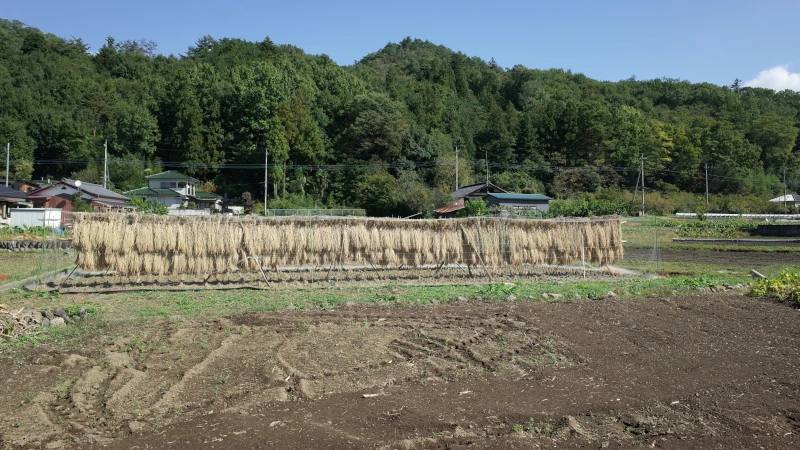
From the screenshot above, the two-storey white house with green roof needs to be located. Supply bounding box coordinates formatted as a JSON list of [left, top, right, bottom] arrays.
[[125, 170, 222, 211]]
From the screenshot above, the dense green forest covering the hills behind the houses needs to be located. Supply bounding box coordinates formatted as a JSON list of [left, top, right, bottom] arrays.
[[0, 19, 800, 215]]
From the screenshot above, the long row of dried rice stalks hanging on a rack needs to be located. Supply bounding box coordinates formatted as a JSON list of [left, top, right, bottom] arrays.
[[74, 214, 622, 275]]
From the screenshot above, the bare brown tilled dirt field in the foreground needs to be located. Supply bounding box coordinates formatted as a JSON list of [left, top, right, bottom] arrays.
[[0, 293, 800, 449]]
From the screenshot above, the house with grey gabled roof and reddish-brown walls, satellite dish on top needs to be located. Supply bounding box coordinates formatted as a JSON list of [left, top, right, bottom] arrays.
[[28, 178, 132, 219]]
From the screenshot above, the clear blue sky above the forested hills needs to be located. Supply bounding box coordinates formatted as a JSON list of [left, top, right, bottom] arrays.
[[6, 0, 800, 90]]
